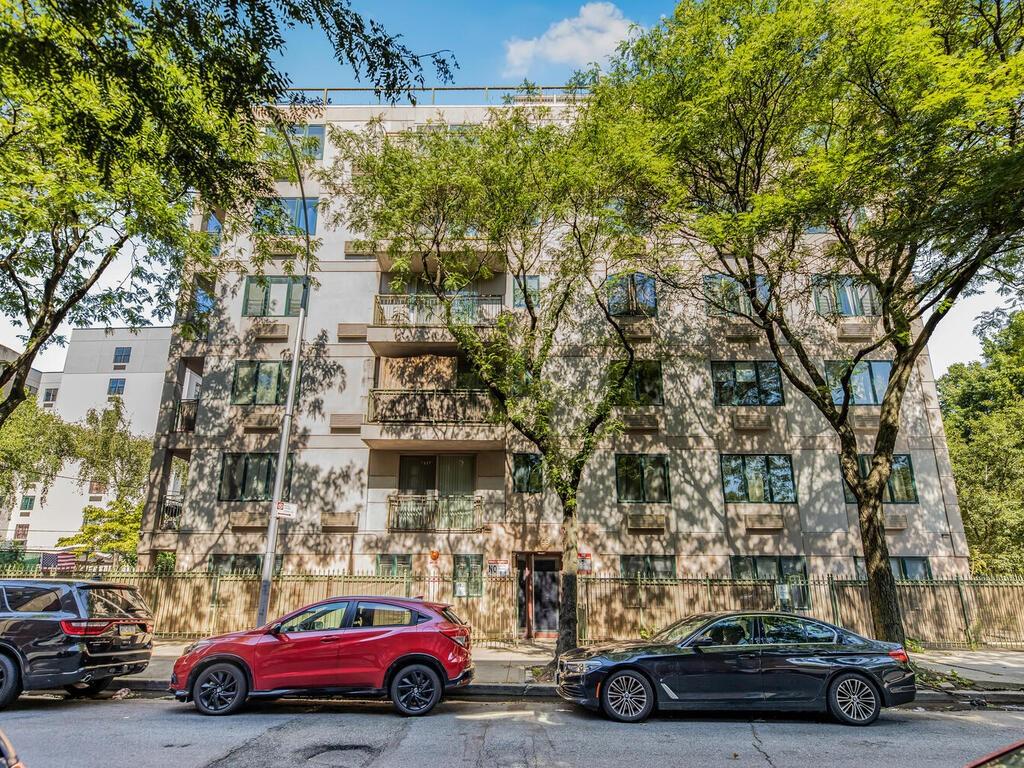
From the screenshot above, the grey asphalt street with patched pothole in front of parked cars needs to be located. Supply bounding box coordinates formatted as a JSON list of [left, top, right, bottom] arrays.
[[0, 695, 1024, 768]]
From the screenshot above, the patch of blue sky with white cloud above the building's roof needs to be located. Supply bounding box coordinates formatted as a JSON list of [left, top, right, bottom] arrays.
[[282, 0, 674, 88]]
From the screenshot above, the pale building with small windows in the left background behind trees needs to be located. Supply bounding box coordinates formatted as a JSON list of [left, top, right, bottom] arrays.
[[3, 327, 172, 553]]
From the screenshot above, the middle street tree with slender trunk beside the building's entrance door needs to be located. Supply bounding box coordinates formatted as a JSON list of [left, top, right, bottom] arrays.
[[322, 105, 654, 651]]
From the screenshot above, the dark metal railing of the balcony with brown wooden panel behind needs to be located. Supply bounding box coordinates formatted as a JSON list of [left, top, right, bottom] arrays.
[[367, 389, 494, 424]]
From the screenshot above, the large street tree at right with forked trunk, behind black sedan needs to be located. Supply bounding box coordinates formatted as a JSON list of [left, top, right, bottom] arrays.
[[594, 0, 1024, 641]]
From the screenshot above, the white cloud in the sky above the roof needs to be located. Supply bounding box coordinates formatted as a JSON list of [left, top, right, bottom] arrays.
[[505, 2, 632, 77]]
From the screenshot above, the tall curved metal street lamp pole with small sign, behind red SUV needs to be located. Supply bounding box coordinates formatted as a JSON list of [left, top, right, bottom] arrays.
[[256, 125, 310, 627]]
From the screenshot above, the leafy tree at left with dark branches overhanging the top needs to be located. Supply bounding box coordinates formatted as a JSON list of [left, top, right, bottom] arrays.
[[0, 0, 454, 424]]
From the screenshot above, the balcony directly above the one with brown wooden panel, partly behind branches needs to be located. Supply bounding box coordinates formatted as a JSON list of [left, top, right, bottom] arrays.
[[367, 294, 504, 355]]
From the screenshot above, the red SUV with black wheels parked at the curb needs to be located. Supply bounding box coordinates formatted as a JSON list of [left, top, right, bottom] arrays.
[[171, 596, 473, 715]]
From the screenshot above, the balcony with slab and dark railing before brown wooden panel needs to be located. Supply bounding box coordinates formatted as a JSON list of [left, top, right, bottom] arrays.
[[360, 389, 505, 451]]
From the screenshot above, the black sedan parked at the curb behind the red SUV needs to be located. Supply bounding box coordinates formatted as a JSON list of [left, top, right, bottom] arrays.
[[557, 611, 916, 725]]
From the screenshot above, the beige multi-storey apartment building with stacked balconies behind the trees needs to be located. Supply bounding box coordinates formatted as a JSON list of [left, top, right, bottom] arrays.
[[139, 105, 968, 632]]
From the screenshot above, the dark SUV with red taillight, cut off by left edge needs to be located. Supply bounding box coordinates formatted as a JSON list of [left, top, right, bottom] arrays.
[[0, 579, 153, 708]]
